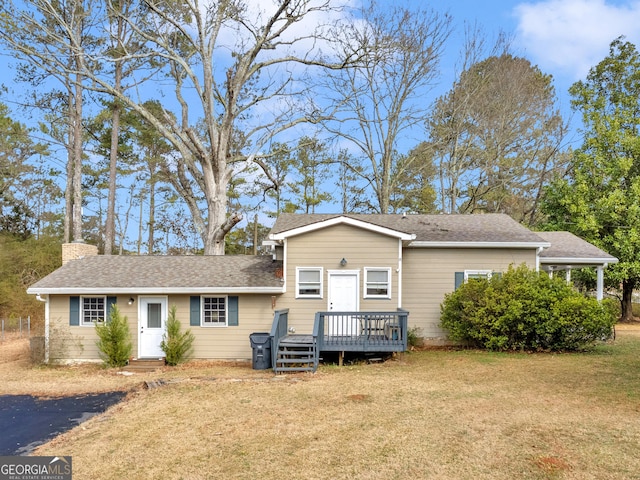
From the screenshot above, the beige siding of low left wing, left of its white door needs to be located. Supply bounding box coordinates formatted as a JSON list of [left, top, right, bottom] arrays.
[[49, 295, 138, 363]]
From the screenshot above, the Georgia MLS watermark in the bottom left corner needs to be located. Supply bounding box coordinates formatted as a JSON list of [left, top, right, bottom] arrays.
[[0, 456, 71, 480]]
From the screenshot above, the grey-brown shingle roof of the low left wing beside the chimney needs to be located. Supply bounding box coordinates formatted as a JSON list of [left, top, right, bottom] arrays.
[[30, 255, 282, 291]]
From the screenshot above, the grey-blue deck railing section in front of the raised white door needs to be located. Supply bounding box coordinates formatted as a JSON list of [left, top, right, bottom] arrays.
[[313, 309, 409, 352]]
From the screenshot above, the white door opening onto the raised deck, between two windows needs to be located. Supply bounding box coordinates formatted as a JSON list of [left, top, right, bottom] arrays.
[[327, 271, 360, 336]]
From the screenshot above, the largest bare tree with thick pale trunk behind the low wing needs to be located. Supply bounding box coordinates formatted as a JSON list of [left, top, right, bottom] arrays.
[[10, 0, 358, 254]]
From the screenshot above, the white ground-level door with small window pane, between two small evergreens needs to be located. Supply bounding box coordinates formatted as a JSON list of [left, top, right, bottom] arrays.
[[138, 297, 167, 358]]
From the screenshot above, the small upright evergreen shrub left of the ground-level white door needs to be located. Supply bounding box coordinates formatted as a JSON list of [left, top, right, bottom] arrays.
[[96, 305, 133, 367]]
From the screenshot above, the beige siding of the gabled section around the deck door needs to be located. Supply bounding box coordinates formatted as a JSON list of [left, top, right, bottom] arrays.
[[277, 225, 399, 333]]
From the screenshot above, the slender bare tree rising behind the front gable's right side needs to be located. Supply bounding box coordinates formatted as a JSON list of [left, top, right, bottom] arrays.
[[322, 2, 451, 213]]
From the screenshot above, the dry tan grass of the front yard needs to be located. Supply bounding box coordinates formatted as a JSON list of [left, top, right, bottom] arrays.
[[0, 326, 640, 479]]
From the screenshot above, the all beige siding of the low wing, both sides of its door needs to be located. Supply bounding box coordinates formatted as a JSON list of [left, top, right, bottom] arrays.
[[49, 295, 273, 363]]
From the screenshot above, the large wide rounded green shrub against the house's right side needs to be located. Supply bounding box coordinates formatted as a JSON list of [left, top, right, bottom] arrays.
[[441, 265, 616, 351]]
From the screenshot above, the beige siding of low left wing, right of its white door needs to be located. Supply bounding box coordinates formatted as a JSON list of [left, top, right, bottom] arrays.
[[169, 294, 273, 360]]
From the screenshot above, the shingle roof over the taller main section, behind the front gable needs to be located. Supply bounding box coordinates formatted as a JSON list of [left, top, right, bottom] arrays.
[[271, 213, 545, 243]]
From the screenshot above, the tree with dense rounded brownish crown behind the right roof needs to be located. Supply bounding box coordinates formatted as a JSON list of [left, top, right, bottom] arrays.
[[427, 47, 567, 225]]
